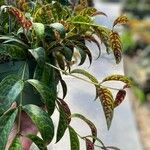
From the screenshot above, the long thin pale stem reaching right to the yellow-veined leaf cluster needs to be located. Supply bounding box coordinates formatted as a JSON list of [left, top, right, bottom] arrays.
[[46, 63, 120, 91]]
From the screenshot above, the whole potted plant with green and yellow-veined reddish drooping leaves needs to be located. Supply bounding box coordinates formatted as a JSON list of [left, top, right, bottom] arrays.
[[0, 0, 131, 150]]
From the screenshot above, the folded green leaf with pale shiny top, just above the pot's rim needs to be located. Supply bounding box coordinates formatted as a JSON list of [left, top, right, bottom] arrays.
[[29, 47, 45, 66]]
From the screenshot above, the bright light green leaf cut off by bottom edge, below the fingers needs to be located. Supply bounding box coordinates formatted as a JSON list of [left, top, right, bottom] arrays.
[[9, 137, 22, 150]]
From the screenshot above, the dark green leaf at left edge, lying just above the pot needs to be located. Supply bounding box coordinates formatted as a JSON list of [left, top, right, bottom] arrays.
[[0, 44, 27, 60]]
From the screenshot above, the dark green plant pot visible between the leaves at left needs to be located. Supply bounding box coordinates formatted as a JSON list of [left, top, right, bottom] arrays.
[[0, 61, 43, 106]]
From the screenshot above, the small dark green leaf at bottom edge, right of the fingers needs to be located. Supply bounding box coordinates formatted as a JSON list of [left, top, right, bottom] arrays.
[[27, 134, 47, 150]]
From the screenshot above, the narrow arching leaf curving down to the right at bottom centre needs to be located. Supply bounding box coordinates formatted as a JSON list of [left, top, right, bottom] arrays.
[[71, 113, 97, 143]]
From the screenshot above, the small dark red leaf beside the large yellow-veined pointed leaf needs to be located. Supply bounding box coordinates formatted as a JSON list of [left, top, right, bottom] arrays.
[[114, 90, 126, 107]]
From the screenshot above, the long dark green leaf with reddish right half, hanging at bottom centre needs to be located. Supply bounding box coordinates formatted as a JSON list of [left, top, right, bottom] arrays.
[[56, 100, 71, 142]]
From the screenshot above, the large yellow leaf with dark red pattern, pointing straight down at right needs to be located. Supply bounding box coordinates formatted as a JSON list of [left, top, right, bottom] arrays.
[[98, 87, 114, 130]]
